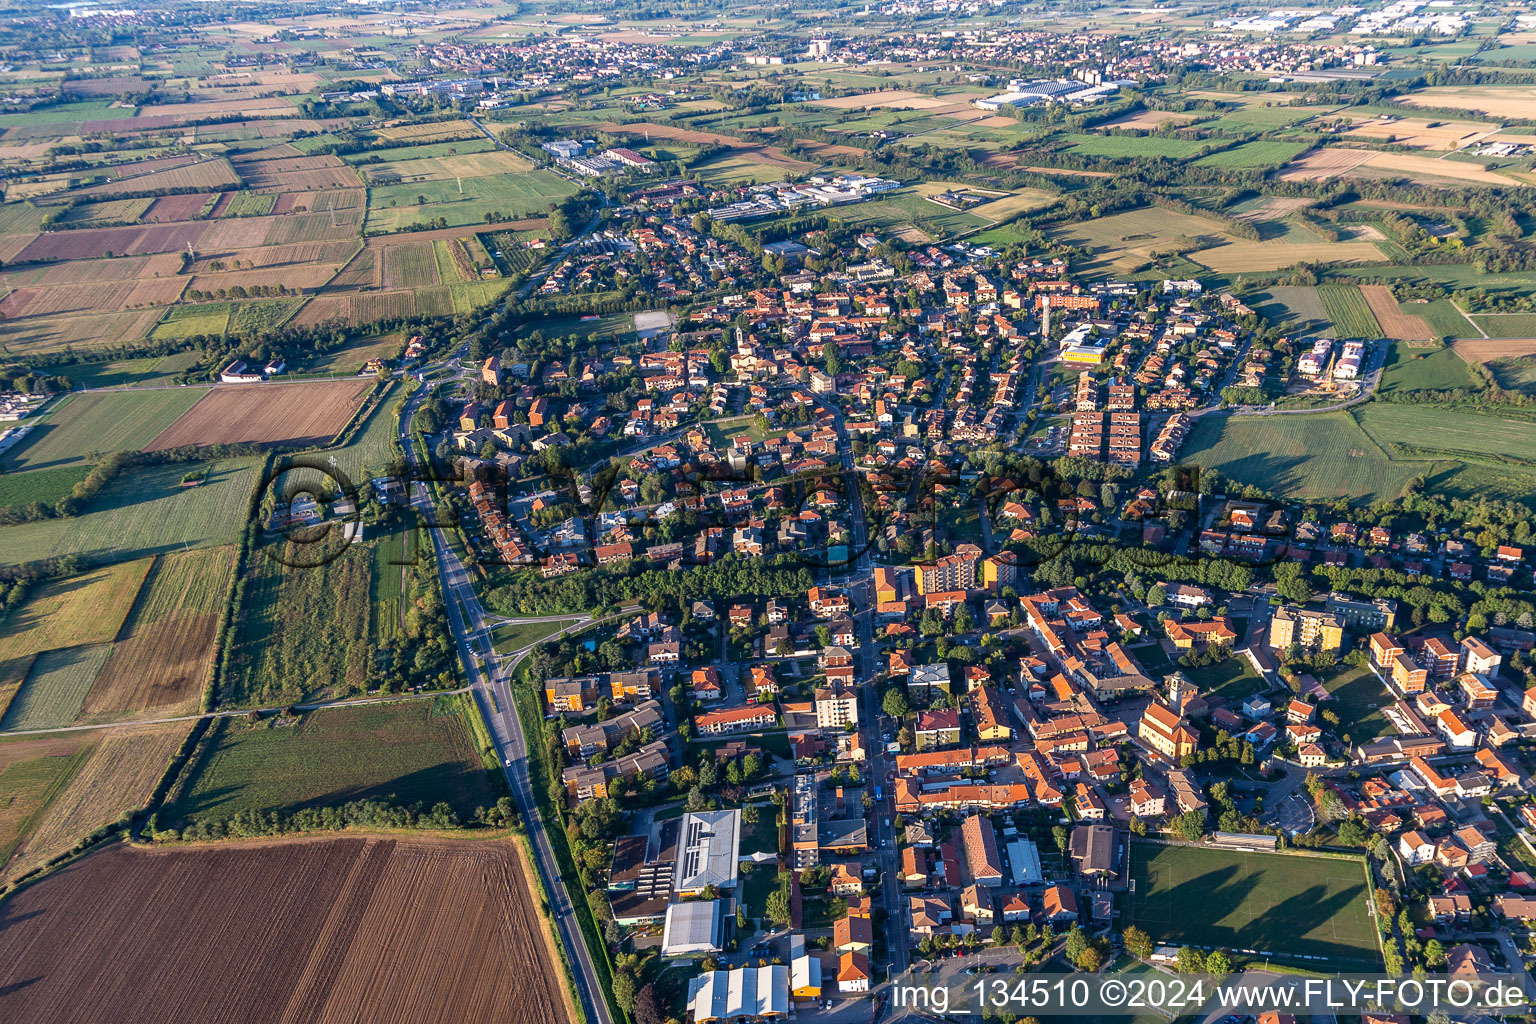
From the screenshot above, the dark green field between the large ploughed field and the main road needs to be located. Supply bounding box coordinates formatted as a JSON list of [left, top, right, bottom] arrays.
[[161, 694, 496, 827]]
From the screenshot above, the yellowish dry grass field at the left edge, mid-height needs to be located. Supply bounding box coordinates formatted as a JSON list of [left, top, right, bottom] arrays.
[[0, 559, 151, 665]]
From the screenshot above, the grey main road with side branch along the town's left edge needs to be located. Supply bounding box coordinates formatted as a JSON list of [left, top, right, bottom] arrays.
[[399, 379, 613, 1024]]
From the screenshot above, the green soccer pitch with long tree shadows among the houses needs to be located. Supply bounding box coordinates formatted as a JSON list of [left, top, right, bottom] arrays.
[[1127, 843, 1381, 966]]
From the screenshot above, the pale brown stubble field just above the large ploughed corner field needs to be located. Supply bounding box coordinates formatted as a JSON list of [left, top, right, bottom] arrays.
[[0, 722, 192, 880]]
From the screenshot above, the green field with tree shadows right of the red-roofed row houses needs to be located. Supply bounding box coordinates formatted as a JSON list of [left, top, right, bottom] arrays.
[[1181, 411, 1428, 502]]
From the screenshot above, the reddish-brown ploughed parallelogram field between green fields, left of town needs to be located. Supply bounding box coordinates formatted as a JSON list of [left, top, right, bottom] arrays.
[[146, 381, 373, 451]]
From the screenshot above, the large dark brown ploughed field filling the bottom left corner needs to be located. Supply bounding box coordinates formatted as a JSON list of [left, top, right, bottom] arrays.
[[0, 837, 567, 1024]]
